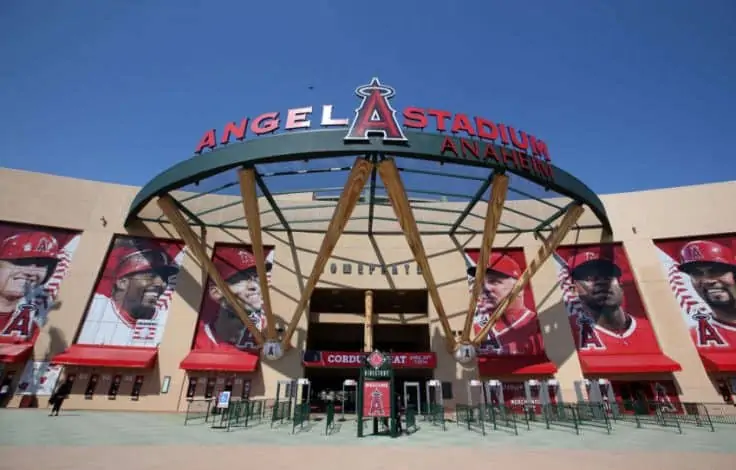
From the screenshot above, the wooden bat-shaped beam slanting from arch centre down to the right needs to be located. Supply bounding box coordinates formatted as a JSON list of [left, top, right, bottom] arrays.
[[378, 159, 455, 352]]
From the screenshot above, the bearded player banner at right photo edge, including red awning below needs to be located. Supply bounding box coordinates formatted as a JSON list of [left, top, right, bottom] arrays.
[[655, 235, 736, 372]]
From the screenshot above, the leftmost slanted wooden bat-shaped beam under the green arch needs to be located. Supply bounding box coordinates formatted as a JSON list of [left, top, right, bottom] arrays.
[[157, 194, 263, 346]]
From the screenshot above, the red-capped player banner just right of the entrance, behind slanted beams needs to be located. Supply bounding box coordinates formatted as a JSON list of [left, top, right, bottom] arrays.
[[465, 250, 544, 356]]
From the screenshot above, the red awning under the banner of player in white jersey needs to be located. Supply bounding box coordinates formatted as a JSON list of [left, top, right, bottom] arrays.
[[52, 344, 158, 369]]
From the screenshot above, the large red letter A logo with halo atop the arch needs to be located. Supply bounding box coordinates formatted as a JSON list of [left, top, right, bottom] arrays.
[[345, 78, 407, 142]]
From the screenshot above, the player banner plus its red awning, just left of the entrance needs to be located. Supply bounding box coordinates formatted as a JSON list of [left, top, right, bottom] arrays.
[[181, 244, 274, 372]]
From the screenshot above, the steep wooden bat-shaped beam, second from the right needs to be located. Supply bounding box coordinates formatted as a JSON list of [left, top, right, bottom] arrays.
[[461, 173, 509, 343]]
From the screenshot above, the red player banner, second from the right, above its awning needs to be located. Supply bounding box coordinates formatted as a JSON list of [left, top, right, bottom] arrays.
[[554, 245, 659, 354]]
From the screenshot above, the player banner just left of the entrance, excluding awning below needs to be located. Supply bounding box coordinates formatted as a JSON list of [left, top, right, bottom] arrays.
[[195, 246, 274, 350]]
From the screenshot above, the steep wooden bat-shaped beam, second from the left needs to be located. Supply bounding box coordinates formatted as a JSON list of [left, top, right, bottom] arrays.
[[238, 168, 276, 340]]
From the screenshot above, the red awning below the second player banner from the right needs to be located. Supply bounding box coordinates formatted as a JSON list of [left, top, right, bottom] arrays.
[[579, 353, 682, 375]]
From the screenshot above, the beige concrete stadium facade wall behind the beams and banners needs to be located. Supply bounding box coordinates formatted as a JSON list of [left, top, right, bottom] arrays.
[[0, 170, 736, 411]]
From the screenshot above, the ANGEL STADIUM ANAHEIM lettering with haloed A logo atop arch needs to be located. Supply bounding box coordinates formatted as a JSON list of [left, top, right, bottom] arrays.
[[194, 78, 553, 180]]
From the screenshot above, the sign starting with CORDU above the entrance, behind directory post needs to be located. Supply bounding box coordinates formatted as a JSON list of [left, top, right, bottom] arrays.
[[302, 350, 437, 369]]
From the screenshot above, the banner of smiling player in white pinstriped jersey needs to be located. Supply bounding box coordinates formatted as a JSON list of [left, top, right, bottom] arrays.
[[77, 236, 184, 347]]
